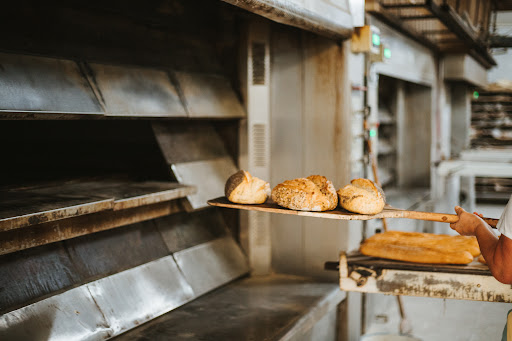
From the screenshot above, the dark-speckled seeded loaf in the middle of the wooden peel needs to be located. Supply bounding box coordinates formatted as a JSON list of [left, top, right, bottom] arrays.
[[272, 175, 338, 212]]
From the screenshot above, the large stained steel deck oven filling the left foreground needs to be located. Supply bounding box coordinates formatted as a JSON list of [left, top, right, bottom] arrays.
[[0, 0, 358, 340]]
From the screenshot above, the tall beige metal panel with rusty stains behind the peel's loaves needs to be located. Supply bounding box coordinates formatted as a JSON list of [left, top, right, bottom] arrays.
[[270, 22, 351, 279]]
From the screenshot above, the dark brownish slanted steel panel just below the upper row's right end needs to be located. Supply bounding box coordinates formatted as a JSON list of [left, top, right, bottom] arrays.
[[152, 122, 228, 164]]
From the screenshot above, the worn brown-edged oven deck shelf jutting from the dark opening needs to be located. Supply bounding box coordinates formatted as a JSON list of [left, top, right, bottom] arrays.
[[0, 180, 195, 232]]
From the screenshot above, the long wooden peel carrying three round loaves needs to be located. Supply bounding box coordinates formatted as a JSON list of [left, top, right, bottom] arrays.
[[208, 197, 498, 228]]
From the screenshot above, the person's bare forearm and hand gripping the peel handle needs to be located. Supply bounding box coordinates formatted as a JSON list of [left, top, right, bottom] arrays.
[[450, 206, 512, 284]]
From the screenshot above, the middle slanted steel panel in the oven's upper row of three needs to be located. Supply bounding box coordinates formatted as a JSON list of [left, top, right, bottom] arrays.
[[90, 64, 187, 117]]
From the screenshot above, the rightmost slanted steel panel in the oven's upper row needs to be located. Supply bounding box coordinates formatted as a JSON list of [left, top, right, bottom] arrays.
[[176, 72, 245, 118]]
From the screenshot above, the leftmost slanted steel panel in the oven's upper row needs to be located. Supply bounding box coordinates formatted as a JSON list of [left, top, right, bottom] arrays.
[[0, 53, 103, 114]]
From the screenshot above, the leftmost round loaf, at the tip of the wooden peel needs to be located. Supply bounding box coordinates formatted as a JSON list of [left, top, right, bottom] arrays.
[[224, 170, 270, 204]]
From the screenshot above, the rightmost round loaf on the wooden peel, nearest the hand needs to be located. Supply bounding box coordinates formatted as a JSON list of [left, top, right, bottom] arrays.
[[337, 179, 386, 214]]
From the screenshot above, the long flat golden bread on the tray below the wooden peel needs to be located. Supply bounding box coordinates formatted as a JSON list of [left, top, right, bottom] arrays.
[[359, 231, 480, 264]]
